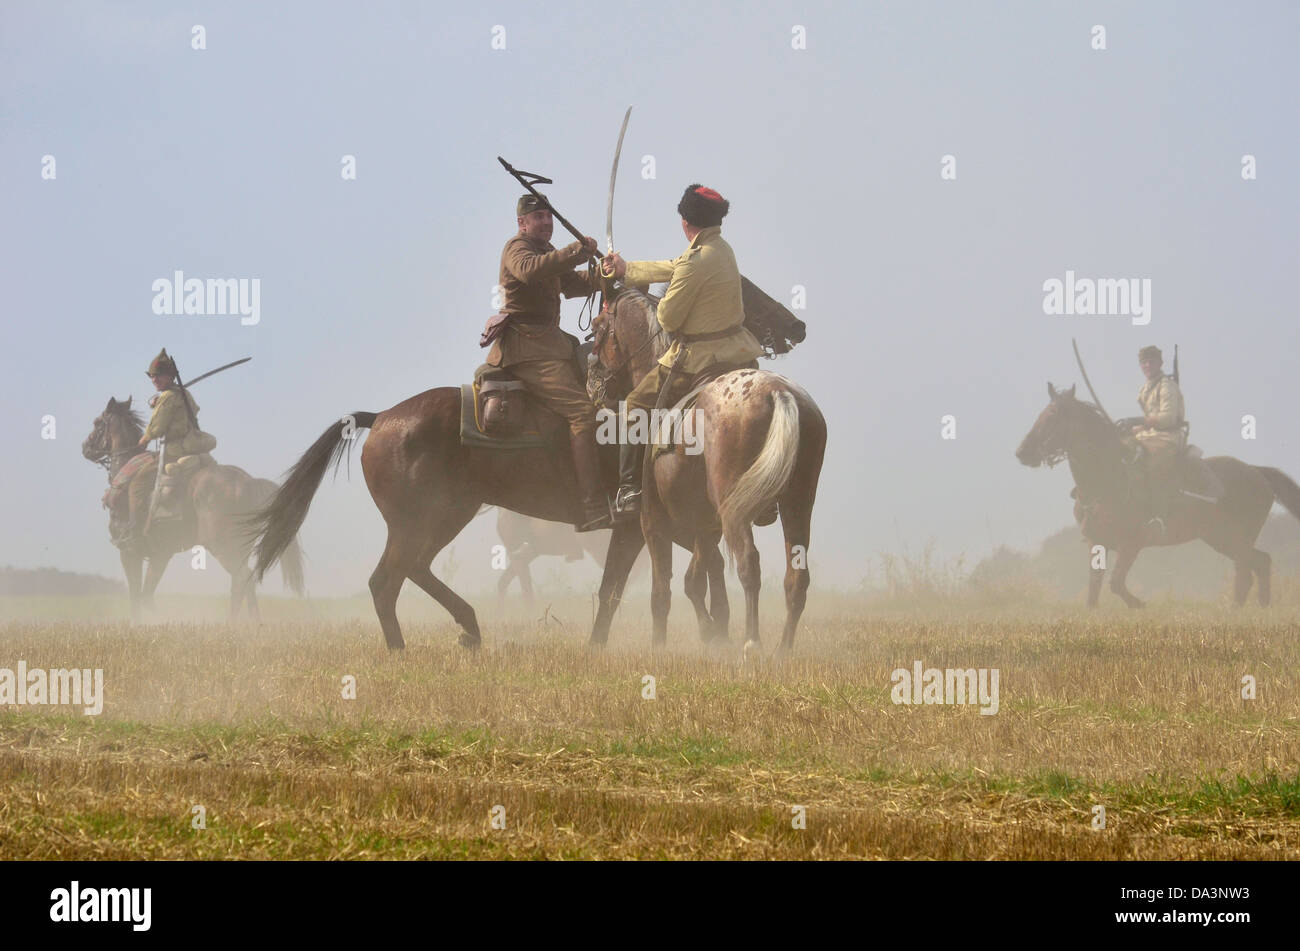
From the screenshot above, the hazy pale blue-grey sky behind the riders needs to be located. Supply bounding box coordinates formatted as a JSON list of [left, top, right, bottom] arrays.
[[0, 0, 1300, 595]]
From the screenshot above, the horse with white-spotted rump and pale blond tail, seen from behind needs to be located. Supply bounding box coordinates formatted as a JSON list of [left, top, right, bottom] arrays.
[[589, 288, 827, 656]]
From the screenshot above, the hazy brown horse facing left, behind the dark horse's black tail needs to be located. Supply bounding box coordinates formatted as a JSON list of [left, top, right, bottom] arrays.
[[82, 398, 304, 621]]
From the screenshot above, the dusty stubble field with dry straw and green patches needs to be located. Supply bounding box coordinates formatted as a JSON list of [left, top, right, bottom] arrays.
[[0, 589, 1300, 859]]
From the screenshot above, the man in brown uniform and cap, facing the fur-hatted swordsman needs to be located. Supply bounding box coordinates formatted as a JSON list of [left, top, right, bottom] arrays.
[[488, 194, 611, 531]]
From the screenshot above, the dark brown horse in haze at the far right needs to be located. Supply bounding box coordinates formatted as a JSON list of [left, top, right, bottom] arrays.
[[1015, 383, 1300, 608]]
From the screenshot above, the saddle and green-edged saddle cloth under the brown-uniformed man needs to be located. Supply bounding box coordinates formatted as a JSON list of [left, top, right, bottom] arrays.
[[460, 364, 568, 450]]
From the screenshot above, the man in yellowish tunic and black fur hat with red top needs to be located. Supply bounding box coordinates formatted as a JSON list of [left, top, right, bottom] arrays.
[[603, 183, 763, 516]]
